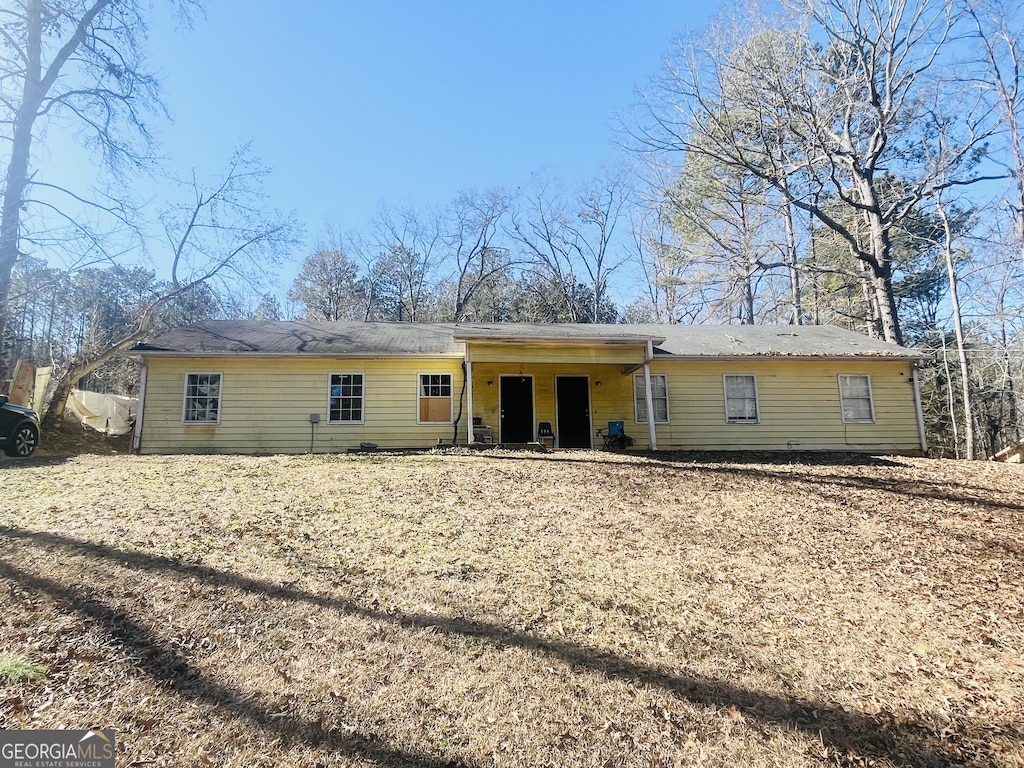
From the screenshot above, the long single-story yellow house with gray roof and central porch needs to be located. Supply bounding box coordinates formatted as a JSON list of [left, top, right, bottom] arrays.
[[128, 321, 927, 454]]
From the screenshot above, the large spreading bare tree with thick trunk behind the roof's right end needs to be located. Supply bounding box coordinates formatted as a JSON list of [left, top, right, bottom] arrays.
[[635, 0, 986, 342]]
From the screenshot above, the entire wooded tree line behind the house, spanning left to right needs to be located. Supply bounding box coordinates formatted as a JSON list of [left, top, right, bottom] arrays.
[[0, 0, 1024, 456]]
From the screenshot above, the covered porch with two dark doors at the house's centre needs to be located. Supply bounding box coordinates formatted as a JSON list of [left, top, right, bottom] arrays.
[[455, 326, 665, 450]]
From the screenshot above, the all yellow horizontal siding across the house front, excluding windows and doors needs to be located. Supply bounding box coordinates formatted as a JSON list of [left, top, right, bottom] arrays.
[[141, 352, 920, 453]]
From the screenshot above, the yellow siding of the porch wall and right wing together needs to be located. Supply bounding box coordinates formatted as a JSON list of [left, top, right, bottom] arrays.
[[471, 358, 921, 452]]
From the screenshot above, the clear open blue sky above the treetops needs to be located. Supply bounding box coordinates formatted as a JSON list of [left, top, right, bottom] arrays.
[[142, 0, 714, 243]]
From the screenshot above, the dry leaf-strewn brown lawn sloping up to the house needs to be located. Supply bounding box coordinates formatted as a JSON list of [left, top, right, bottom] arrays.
[[0, 453, 1024, 768]]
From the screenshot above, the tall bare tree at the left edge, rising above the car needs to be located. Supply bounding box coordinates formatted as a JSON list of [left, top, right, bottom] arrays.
[[0, 0, 193, 378]]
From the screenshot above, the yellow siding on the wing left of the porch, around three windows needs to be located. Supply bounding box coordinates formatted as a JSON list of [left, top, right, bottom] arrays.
[[140, 357, 469, 454]]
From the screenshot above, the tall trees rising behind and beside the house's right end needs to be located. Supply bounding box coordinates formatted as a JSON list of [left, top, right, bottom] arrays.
[[632, 0, 1024, 458]]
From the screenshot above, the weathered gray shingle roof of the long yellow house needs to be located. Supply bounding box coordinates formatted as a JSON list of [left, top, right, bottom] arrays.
[[135, 321, 924, 358]]
